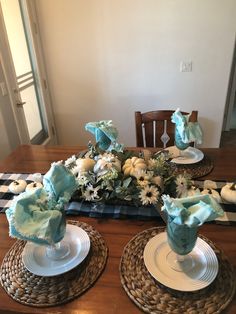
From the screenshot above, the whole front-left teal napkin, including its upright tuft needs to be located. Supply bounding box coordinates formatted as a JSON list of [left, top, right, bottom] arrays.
[[6, 163, 77, 245]]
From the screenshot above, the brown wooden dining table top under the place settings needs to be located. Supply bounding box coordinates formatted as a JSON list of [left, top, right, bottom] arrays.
[[0, 145, 236, 314]]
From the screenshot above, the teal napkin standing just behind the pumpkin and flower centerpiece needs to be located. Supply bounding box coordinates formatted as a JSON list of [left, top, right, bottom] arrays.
[[85, 120, 123, 151]]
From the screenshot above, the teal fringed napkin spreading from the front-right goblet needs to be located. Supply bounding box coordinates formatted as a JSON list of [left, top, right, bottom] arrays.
[[162, 194, 224, 227]]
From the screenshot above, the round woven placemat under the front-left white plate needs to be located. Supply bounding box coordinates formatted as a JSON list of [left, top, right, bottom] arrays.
[[0, 221, 108, 307]]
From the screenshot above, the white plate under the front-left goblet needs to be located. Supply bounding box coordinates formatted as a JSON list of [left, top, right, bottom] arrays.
[[22, 224, 90, 276]]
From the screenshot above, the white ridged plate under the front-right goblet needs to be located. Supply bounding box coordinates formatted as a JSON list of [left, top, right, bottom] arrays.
[[144, 232, 219, 291]]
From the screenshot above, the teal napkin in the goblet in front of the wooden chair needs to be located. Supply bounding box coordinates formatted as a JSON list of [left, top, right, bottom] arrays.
[[171, 109, 203, 144]]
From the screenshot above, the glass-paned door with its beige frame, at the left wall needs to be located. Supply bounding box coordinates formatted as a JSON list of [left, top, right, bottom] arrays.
[[0, 0, 57, 144]]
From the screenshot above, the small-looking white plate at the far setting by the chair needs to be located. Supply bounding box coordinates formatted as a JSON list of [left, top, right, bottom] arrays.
[[165, 146, 204, 165]]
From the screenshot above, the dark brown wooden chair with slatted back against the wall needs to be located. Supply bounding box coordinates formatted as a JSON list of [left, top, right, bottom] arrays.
[[135, 110, 198, 148]]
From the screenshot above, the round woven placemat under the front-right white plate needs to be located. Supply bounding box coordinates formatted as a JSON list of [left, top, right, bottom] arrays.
[[120, 227, 235, 314]]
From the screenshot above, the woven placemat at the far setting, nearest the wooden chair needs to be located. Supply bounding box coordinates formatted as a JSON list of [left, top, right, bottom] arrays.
[[171, 155, 214, 179]]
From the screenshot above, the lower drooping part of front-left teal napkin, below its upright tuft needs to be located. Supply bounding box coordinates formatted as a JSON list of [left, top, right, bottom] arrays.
[[6, 188, 65, 244]]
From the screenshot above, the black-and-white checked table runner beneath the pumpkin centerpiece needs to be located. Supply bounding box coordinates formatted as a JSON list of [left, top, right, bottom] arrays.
[[0, 173, 236, 225]]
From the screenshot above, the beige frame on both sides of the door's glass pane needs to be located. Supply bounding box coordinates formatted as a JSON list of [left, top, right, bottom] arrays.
[[0, 0, 57, 145]]
